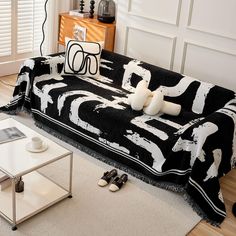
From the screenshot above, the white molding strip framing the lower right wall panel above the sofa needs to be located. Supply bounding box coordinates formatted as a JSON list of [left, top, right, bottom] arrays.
[[180, 41, 236, 74]]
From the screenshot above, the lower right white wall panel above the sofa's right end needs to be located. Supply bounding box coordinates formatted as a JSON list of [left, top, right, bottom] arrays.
[[182, 43, 236, 90]]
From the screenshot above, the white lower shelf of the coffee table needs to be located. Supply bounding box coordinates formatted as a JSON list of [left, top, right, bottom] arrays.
[[0, 171, 69, 224]]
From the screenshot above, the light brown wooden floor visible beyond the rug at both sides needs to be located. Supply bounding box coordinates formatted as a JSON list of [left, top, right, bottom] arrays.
[[0, 75, 236, 236]]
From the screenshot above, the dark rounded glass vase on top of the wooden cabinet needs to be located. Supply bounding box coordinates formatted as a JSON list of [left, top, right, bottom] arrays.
[[97, 0, 116, 23]]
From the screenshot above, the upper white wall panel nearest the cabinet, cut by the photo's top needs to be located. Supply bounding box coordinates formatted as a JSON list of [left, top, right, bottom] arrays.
[[129, 0, 181, 24]]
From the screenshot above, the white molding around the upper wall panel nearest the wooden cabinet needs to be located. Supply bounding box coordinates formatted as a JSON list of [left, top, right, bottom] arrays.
[[127, 0, 182, 26]]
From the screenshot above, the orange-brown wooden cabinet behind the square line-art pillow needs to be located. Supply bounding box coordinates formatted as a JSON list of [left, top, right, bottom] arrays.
[[58, 13, 116, 51]]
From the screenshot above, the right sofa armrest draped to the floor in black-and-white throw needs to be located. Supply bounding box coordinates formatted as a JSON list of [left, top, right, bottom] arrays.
[[173, 99, 236, 222]]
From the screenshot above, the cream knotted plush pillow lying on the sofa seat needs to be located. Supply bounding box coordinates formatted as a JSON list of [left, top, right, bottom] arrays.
[[128, 80, 181, 116]]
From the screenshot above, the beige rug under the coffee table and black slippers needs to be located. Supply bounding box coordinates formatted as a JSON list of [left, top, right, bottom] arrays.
[[0, 114, 200, 236]]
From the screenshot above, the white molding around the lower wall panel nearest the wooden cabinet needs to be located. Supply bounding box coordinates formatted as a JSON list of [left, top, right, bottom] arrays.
[[124, 26, 177, 70]]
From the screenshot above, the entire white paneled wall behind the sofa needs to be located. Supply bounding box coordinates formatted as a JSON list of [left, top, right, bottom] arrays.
[[115, 0, 236, 91]]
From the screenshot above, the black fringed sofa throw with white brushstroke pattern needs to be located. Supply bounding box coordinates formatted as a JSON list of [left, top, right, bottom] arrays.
[[1, 51, 236, 224]]
